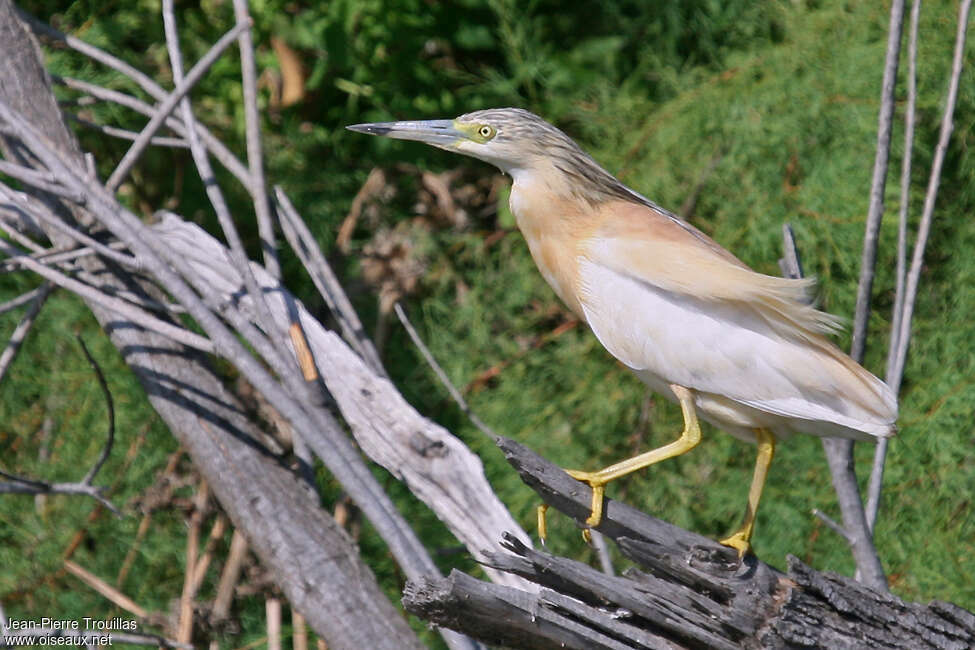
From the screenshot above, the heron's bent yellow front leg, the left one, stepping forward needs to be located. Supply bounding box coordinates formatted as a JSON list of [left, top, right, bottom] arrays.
[[539, 384, 701, 542]]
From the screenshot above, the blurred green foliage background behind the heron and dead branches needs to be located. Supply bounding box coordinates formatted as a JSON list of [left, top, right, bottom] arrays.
[[0, 0, 975, 647]]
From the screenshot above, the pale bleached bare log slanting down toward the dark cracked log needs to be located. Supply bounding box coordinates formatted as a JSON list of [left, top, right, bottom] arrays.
[[153, 215, 532, 589]]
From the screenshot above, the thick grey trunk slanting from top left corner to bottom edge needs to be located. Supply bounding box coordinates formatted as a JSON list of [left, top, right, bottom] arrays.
[[0, 0, 421, 649]]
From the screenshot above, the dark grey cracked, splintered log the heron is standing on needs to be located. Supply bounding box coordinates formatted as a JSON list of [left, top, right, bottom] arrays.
[[403, 440, 975, 650]]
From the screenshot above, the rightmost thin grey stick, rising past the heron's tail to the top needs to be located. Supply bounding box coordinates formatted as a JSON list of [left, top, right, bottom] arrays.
[[867, 0, 972, 529]]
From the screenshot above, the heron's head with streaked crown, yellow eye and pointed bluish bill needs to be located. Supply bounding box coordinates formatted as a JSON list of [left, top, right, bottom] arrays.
[[346, 108, 647, 203]]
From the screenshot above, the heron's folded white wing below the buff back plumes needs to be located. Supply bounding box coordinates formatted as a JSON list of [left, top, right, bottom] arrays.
[[579, 257, 896, 435]]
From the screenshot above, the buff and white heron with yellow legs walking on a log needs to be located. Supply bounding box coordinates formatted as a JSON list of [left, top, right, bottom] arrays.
[[348, 108, 897, 556]]
